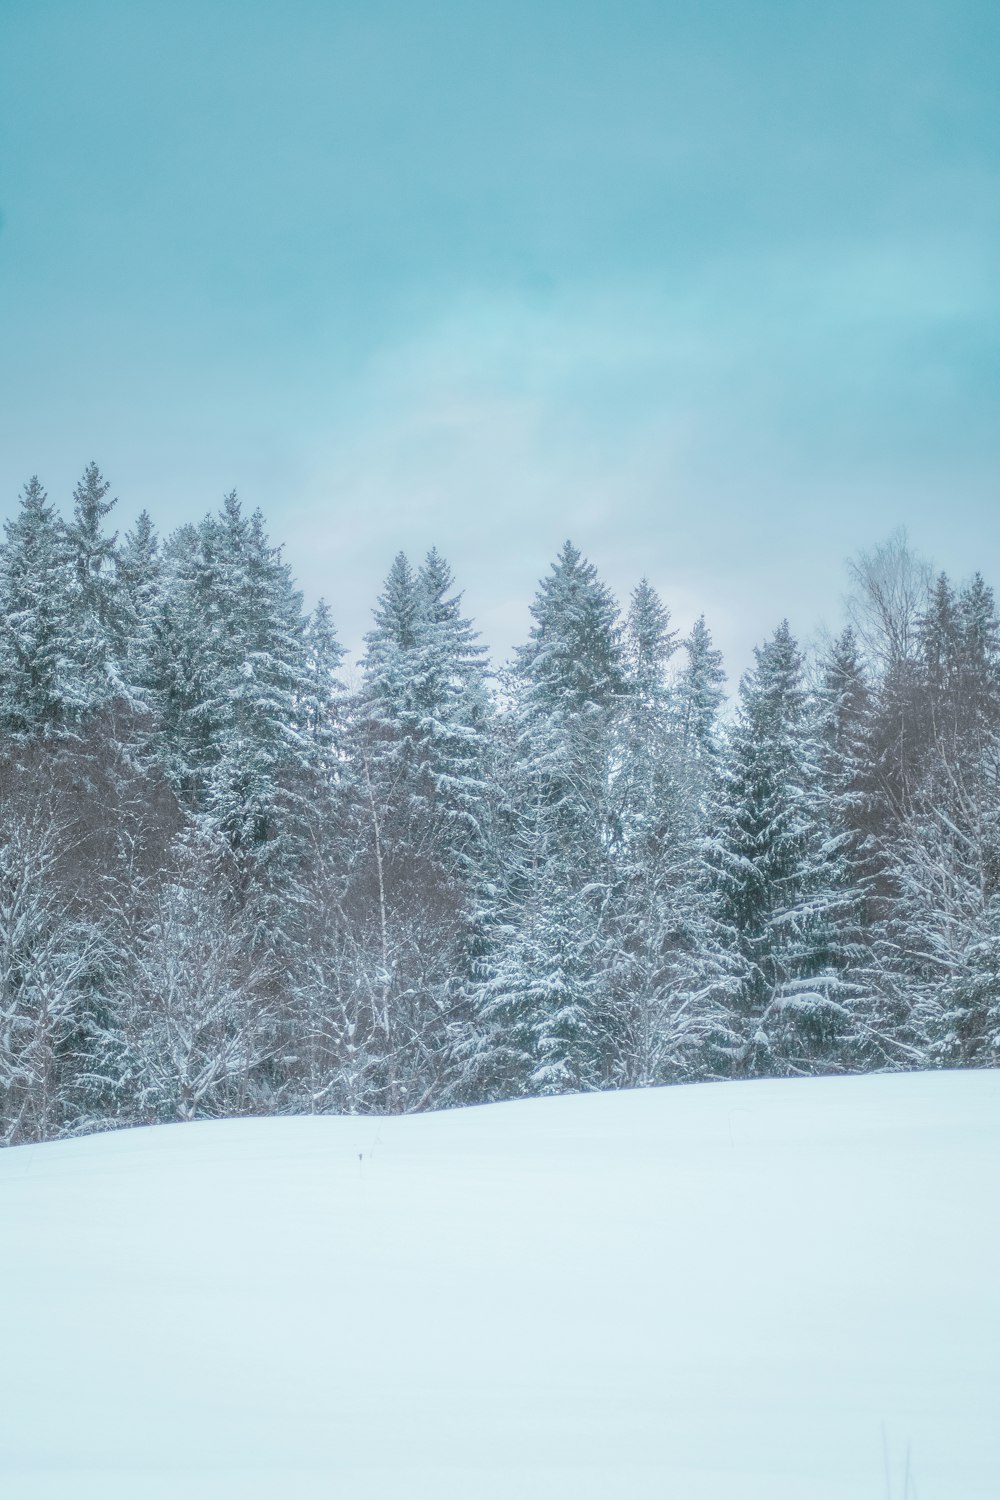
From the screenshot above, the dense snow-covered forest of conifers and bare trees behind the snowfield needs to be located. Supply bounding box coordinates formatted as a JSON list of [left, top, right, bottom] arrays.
[[0, 464, 1000, 1145]]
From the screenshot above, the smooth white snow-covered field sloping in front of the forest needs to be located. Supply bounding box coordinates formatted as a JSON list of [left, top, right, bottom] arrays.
[[0, 1073, 1000, 1500]]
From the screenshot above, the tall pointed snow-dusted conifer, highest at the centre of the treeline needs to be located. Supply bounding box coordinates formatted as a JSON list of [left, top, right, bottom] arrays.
[[478, 542, 628, 1094]]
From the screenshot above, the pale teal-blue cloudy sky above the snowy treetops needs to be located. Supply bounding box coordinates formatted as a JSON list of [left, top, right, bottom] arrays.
[[0, 0, 1000, 674]]
